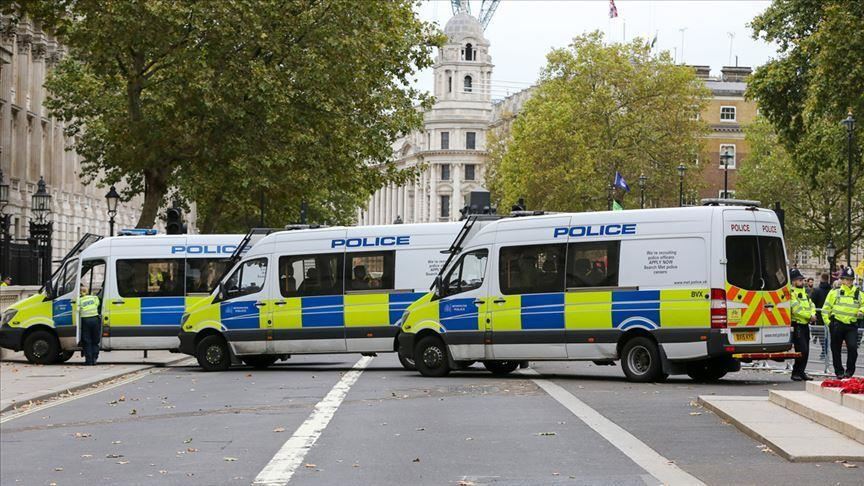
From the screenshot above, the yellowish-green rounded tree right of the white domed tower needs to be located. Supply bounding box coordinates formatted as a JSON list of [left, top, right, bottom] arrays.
[[488, 32, 707, 211]]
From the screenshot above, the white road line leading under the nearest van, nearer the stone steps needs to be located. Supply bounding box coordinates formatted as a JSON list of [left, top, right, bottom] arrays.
[[521, 369, 705, 486]]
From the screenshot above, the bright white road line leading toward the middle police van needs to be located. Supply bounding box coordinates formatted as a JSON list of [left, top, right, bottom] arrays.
[[252, 356, 373, 486]]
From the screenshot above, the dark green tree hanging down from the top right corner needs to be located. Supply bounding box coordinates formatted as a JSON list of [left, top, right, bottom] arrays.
[[741, 0, 864, 260]]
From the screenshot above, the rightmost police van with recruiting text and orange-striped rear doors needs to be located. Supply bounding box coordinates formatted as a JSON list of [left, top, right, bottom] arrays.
[[399, 200, 794, 382]]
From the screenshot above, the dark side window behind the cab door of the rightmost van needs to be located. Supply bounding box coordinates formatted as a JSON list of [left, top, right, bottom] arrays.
[[498, 244, 566, 295]]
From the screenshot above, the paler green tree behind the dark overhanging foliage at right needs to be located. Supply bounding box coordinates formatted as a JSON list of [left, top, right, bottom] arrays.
[[737, 117, 864, 251]]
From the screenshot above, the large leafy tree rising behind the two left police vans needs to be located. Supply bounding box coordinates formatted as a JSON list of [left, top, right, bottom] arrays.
[[35, 0, 441, 231]]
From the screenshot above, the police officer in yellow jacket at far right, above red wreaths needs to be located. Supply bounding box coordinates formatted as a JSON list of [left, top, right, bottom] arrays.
[[822, 268, 864, 378]]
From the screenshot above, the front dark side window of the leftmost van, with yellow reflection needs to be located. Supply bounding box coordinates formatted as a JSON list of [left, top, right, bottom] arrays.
[[117, 258, 185, 297]]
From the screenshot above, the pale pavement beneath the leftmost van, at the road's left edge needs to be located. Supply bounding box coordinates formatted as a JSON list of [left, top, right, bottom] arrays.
[[0, 351, 188, 413]]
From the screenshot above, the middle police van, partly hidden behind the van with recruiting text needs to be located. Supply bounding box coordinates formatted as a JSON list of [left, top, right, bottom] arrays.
[[180, 223, 462, 371]]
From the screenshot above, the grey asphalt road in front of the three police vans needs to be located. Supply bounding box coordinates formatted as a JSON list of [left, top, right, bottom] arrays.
[[0, 355, 864, 485]]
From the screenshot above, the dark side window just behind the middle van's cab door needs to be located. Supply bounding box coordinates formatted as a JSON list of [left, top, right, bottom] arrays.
[[279, 253, 345, 297]]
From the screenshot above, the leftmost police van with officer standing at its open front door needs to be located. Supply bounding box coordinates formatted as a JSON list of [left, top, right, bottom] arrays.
[[0, 234, 242, 364]]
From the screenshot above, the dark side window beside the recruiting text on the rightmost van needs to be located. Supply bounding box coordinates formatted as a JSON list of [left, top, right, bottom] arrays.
[[567, 241, 621, 289]]
